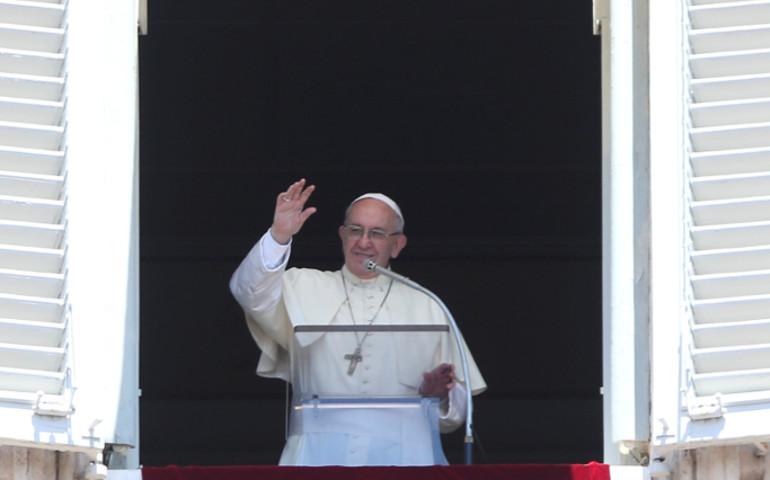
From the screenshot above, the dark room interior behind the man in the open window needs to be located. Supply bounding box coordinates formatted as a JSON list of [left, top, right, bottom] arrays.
[[140, 0, 602, 466]]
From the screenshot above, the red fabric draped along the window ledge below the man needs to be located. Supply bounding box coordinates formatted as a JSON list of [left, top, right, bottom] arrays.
[[142, 462, 610, 480]]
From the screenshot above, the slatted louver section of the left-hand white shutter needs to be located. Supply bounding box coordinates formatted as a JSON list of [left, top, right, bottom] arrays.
[[0, 0, 71, 414]]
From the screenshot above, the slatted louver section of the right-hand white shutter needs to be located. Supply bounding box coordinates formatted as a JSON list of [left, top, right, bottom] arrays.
[[689, 0, 770, 407]]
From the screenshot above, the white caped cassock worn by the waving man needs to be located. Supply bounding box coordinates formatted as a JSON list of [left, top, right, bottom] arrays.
[[230, 233, 486, 466]]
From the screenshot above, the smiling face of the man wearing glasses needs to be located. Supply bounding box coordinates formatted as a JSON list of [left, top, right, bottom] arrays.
[[339, 198, 406, 278]]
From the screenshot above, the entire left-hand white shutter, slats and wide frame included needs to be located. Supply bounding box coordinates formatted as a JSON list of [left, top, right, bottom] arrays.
[[0, 0, 139, 466]]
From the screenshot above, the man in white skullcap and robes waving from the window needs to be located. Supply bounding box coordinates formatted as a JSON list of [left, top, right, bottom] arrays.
[[230, 179, 486, 466]]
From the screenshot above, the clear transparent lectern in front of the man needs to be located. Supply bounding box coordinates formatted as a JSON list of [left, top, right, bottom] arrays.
[[287, 325, 451, 465]]
